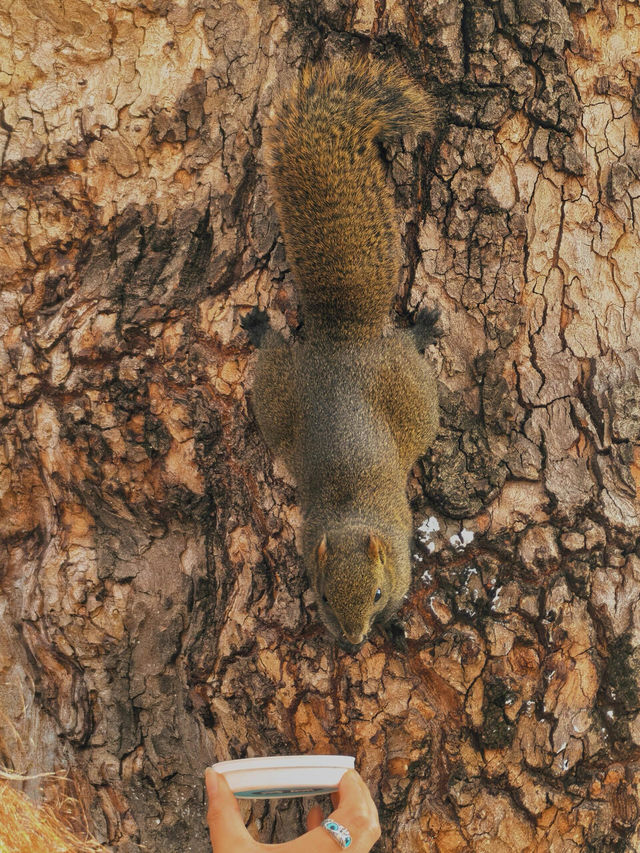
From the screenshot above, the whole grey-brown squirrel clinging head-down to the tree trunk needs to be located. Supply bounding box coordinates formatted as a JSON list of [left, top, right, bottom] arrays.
[[243, 59, 440, 647]]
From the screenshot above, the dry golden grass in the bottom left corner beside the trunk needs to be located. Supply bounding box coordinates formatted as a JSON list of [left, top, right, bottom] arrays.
[[0, 779, 107, 853]]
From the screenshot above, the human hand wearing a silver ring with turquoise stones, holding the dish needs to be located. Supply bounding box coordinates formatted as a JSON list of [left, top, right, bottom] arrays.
[[205, 768, 380, 853]]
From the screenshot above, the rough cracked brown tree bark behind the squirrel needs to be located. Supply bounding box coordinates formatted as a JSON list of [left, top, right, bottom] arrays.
[[0, 0, 640, 853]]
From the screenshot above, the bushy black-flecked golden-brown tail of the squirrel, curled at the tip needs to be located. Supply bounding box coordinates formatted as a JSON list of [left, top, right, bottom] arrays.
[[267, 59, 437, 337]]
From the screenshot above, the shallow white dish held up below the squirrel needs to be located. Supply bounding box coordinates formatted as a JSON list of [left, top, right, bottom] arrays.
[[212, 755, 354, 800]]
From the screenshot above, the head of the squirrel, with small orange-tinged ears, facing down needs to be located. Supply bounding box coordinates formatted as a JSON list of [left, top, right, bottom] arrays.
[[313, 527, 396, 646]]
